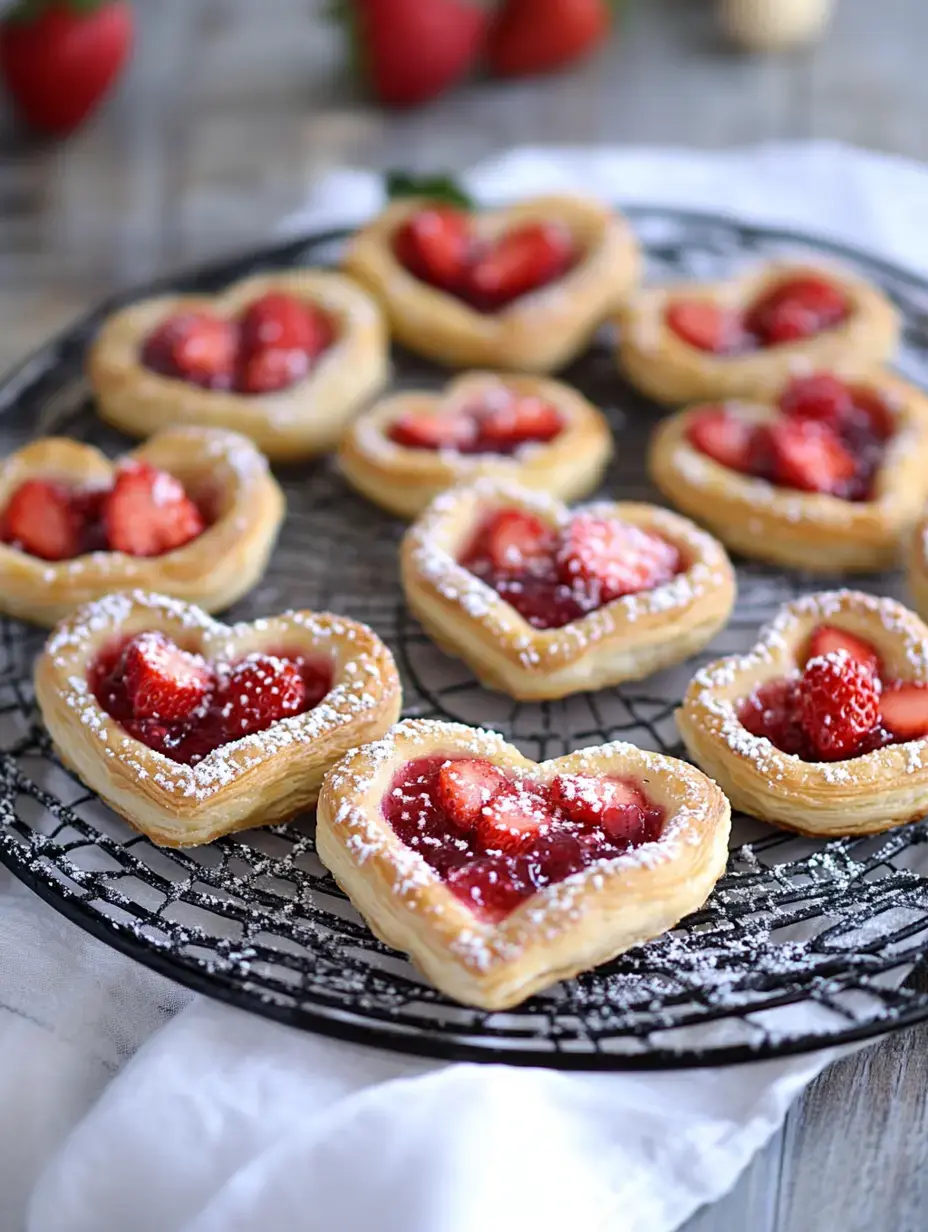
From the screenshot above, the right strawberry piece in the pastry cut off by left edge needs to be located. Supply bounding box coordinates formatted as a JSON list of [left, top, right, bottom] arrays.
[[104, 462, 205, 556]]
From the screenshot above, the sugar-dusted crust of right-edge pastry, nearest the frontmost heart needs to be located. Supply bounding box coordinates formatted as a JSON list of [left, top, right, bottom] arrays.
[[677, 590, 928, 837]]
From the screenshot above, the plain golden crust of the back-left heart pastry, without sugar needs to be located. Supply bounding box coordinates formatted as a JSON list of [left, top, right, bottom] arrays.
[[88, 270, 389, 462]]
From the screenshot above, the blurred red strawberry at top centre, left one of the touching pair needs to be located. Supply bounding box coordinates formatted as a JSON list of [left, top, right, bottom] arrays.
[[345, 0, 488, 107]]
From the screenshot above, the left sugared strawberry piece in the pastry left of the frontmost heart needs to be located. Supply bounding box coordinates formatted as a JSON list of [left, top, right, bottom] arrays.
[[120, 633, 212, 722]]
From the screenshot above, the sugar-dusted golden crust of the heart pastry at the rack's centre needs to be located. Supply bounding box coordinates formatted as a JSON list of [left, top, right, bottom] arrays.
[[401, 480, 735, 700]]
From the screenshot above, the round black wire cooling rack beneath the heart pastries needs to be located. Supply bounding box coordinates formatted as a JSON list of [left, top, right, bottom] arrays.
[[0, 208, 928, 1069]]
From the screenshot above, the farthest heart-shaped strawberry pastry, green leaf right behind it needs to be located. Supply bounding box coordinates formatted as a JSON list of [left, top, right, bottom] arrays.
[[344, 196, 641, 372]]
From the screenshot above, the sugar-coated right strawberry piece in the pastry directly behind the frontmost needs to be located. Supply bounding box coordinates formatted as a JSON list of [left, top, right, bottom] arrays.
[[558, 514, 680, 604]]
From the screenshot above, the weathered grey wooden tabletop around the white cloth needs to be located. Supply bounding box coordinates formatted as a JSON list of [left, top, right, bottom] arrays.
[[0, 0, 928, 1232]]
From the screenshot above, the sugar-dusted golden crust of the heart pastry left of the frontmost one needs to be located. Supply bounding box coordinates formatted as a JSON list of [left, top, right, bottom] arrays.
[[36, 591, 402, 846]]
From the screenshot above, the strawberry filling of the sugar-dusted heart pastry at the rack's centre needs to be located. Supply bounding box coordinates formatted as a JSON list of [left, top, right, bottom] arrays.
[[461, 509, 685, 628]]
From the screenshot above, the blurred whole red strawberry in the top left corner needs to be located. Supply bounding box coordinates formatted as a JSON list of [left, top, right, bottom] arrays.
[[0, 0, 133, 134]]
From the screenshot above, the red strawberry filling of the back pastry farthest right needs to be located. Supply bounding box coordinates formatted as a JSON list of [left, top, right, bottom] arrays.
[[665, 275, 850, 355]]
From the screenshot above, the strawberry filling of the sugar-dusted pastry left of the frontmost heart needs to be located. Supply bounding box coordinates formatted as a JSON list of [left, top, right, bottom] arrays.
[[89, 632, 333, 765]]
